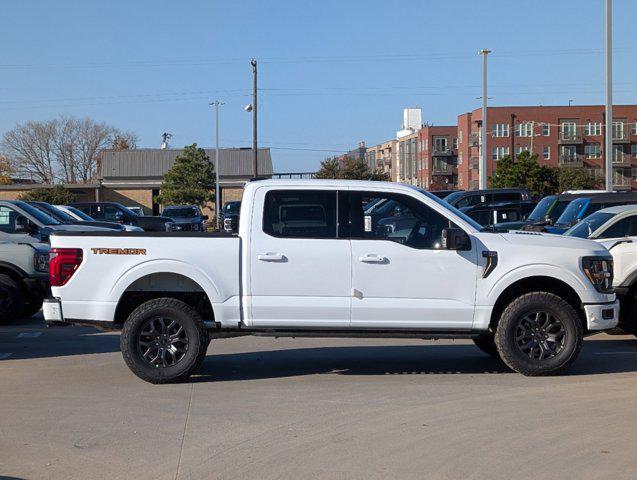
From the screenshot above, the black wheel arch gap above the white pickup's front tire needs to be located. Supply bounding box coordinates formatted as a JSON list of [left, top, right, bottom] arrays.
[[489, 275, 586, 332]]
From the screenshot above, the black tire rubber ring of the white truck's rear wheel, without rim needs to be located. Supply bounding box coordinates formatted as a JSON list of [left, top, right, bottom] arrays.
[[120, 298, 208, 384]]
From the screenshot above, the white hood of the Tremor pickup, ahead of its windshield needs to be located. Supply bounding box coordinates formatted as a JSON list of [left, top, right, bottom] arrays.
[[476, 231, 610, 256]]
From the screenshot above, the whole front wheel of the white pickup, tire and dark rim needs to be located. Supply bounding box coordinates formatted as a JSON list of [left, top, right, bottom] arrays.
[[495, 292, 583, 376]]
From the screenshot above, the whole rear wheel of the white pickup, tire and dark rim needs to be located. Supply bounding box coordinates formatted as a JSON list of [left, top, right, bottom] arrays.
[[120, 298, 208, 383]]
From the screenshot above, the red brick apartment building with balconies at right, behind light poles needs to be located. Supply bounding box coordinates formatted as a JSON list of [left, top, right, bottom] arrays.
[[457, 105, 637, 190]]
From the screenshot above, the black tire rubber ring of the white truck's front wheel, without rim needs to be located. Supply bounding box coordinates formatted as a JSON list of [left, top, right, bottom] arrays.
[[494, 292, 583, 376]]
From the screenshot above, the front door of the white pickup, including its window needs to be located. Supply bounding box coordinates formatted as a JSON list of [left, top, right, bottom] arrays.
[[349, 191, 478, 330]]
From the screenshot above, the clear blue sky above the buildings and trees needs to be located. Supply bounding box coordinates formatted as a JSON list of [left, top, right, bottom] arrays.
[[0, 0, 637, 172]]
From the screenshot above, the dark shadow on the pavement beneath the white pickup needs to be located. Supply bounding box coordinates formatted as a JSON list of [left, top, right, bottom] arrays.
[[192, 340, 637, 382]]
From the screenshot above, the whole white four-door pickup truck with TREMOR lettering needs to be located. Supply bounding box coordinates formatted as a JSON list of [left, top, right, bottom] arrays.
[[44, 180, 619, 383]]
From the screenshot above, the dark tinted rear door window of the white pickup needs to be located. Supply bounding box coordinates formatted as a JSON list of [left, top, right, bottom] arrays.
[[263, 190, 336, 238]]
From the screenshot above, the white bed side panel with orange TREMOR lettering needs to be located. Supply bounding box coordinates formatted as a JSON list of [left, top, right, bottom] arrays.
[[51, 231, 241, 326]]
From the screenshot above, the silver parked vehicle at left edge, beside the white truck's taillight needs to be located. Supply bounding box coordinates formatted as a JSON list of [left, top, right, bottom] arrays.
[[0, 238, 50, 325]]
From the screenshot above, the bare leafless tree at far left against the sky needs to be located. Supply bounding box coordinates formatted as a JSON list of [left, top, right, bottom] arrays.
[[2, 117, 137, 183]]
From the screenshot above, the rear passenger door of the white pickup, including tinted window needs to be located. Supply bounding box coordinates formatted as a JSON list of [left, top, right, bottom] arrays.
[[244, 187, 352, 328]]
